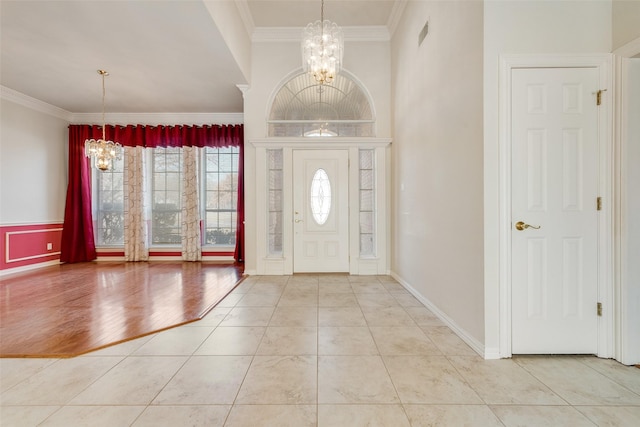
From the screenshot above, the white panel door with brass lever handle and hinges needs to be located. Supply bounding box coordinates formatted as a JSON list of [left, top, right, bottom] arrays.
[[511, 68, 598, 354]]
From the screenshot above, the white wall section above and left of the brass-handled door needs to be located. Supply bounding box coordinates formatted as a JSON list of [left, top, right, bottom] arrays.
[[484, 0, 612, 355]]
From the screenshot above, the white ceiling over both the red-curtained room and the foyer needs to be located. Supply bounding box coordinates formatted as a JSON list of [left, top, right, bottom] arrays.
[[0, 0, 400, 113]]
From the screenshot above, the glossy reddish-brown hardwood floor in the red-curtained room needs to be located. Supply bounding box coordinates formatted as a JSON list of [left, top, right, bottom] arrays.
[[0, 261, 243, 357]]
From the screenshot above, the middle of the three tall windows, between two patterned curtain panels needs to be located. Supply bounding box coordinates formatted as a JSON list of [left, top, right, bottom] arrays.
[[151, 147, 182, 245]]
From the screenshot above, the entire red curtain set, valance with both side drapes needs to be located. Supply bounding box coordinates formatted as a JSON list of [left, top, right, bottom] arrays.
[[60, 124, 244, 262]]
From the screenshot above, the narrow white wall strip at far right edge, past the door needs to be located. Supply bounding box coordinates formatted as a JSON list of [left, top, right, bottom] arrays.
[[620, 59, 640, 364]]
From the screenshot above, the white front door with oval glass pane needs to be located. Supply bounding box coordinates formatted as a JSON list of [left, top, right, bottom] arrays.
[[293, 150, 349, 273]]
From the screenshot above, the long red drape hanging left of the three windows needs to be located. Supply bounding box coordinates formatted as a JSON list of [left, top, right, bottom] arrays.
[[60, 126, 97, 263]]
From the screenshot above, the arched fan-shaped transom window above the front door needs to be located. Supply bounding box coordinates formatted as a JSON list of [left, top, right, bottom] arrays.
[[268, 73, 375, 137]]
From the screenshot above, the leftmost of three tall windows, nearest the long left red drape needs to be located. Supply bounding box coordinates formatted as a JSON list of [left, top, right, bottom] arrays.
[[92, 156, 124, 246]]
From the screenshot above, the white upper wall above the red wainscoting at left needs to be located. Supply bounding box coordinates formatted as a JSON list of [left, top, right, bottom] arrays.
[[0, 99, 68, 225]]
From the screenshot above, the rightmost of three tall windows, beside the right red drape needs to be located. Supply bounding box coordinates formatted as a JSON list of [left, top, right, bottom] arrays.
[[203, 147, 239, 246]]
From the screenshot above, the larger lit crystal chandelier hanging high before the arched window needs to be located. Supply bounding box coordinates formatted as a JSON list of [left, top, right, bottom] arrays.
[[302, 0, 344, 84]]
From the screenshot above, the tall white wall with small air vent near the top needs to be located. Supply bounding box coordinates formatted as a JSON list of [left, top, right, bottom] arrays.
[[391, 1, 484, 352]]
